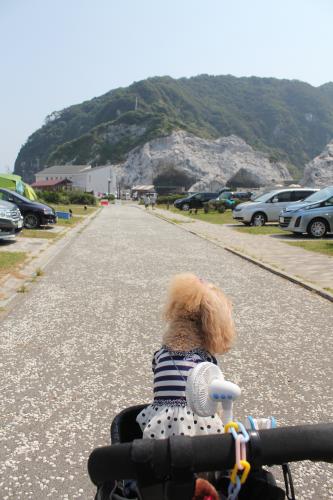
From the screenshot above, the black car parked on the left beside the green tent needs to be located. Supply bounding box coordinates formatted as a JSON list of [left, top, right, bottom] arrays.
[[0, 188, 57, 229]]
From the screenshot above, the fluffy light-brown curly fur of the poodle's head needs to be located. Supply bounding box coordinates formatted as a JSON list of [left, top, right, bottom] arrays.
[[163, 273, 235, 354]]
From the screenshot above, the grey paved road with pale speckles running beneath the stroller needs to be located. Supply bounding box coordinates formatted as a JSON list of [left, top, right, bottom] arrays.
[[0, 206, 333, 500]]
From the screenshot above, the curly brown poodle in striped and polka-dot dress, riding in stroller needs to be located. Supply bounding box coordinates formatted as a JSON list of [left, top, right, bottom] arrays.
[[137, 273, 235, 439]]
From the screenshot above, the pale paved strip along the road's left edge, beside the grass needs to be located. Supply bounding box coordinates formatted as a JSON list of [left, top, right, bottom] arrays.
[[0, 208, 101, 321]]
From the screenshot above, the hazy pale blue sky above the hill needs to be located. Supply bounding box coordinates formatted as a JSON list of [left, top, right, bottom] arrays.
[[0, 0, 333, 171]]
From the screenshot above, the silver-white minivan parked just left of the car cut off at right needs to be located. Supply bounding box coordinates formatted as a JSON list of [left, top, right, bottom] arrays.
[[233, 188, 318, 226]]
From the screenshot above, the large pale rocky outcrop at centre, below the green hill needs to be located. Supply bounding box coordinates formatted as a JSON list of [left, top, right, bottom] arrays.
[[116, 130, 291, 191]]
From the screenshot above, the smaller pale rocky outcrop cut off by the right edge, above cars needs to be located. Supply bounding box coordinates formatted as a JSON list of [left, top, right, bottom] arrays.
[[301, 140, 333, 188]]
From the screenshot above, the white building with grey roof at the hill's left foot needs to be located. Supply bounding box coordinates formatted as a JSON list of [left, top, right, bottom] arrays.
[[35, 165, 117, 196]]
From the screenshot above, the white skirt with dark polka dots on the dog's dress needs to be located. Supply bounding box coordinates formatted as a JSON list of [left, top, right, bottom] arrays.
[[136, 404, 223, 439]]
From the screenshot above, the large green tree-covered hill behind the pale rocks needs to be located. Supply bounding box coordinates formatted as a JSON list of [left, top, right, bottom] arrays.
[[15, 75, 333, 181]]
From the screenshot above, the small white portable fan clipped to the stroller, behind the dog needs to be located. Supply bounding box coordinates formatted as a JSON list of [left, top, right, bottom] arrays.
[[185, 361, 241, 424]]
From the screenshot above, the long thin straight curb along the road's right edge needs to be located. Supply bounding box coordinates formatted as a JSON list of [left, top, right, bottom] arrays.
[[149, 208, 333, 302]]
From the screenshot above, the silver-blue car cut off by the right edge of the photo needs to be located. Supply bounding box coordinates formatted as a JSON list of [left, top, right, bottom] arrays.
[[279, 186, 333, 238]]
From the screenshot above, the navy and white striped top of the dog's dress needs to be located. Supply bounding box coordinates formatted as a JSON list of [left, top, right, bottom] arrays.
[[153, 346, 217, 406]]
